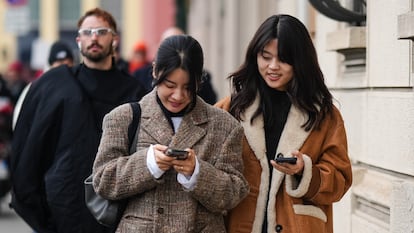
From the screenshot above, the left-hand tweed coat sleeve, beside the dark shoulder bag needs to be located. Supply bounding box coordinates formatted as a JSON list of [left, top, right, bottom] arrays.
[[93, 104, 160, 200]]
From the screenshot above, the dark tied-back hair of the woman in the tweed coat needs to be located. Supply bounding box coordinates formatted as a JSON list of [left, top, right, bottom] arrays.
[[154, 35, 204, 109]]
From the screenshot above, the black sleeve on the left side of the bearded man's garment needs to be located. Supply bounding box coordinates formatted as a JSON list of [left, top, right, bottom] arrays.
[[10, 80, 61, 232]]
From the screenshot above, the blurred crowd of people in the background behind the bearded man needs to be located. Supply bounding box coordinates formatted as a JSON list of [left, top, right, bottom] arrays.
[[0, 23, 217, 215]]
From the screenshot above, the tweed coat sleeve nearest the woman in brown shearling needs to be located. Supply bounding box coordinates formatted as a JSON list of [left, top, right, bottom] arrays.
[[191, 124, 249, 213]]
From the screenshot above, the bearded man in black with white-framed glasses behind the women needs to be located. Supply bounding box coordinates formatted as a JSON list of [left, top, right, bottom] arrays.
[[10, 8, 145, 233]]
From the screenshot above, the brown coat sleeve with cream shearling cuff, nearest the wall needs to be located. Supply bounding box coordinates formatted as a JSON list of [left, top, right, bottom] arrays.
[[287, 109, 352, 205]]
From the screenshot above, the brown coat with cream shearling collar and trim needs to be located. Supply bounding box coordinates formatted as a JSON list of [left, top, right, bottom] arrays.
[[216, 97, 352, 233]]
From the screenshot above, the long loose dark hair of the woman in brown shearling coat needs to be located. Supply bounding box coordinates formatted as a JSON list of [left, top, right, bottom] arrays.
[[228, 14, 333, 131]]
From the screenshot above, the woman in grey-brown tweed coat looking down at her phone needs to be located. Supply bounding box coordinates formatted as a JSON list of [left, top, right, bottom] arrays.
[[93, 35, 249, 233]]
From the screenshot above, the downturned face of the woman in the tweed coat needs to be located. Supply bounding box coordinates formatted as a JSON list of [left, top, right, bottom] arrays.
[[157, 68, 191, 113]]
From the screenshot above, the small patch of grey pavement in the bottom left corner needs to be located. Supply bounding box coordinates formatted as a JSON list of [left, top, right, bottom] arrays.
[[0, 195, 33, 233]]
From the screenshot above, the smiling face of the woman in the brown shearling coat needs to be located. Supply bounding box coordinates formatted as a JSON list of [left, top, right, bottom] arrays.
[[257, 39, 293, 91]]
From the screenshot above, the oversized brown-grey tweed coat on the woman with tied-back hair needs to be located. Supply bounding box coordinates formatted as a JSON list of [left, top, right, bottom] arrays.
[[93, 88, 249, 233]]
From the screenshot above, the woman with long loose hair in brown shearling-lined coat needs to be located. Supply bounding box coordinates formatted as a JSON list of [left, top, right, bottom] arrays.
[[216, 15, 352, 233]]
